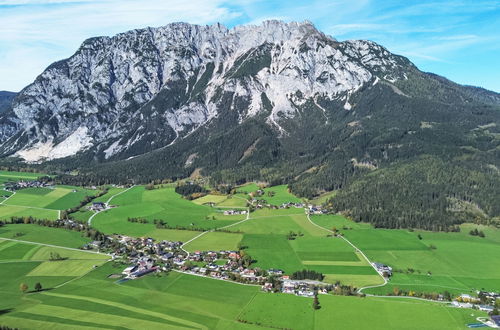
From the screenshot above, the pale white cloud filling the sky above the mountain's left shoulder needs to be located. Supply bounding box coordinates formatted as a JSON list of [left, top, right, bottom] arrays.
[[0, 0, 241, 90]]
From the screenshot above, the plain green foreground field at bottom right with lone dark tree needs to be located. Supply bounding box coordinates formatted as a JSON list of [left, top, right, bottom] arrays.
[[240, 293, 483, 330]]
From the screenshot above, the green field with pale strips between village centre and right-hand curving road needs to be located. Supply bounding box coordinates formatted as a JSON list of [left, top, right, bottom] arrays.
[[230, 213, 383, 287]]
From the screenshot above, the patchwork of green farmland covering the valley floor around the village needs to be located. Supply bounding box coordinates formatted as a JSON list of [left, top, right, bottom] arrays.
[[0, 172, 494, 330]]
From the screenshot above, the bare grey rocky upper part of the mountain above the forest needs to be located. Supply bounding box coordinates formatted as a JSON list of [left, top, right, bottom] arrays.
[[0, 21, 412, 162]]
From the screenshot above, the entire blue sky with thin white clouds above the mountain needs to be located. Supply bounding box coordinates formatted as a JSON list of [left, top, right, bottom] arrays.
[[0, 0, 500, 92]]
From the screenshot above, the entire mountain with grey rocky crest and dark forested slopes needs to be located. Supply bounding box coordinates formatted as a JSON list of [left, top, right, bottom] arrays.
[[0, 21, 500, 229]]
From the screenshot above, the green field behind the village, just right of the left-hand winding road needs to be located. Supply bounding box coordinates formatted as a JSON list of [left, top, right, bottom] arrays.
[[92, 186, 242, 238]]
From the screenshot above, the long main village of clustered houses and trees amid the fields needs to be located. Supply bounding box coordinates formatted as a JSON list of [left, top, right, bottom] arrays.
[[84, 235, 334, 297]]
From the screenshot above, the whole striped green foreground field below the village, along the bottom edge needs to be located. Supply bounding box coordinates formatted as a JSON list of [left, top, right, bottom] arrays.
[[0, 263, 484, 330]]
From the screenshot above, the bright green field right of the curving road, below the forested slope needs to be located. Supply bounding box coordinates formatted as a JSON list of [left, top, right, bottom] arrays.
[[313, 216, 500, 294]]
